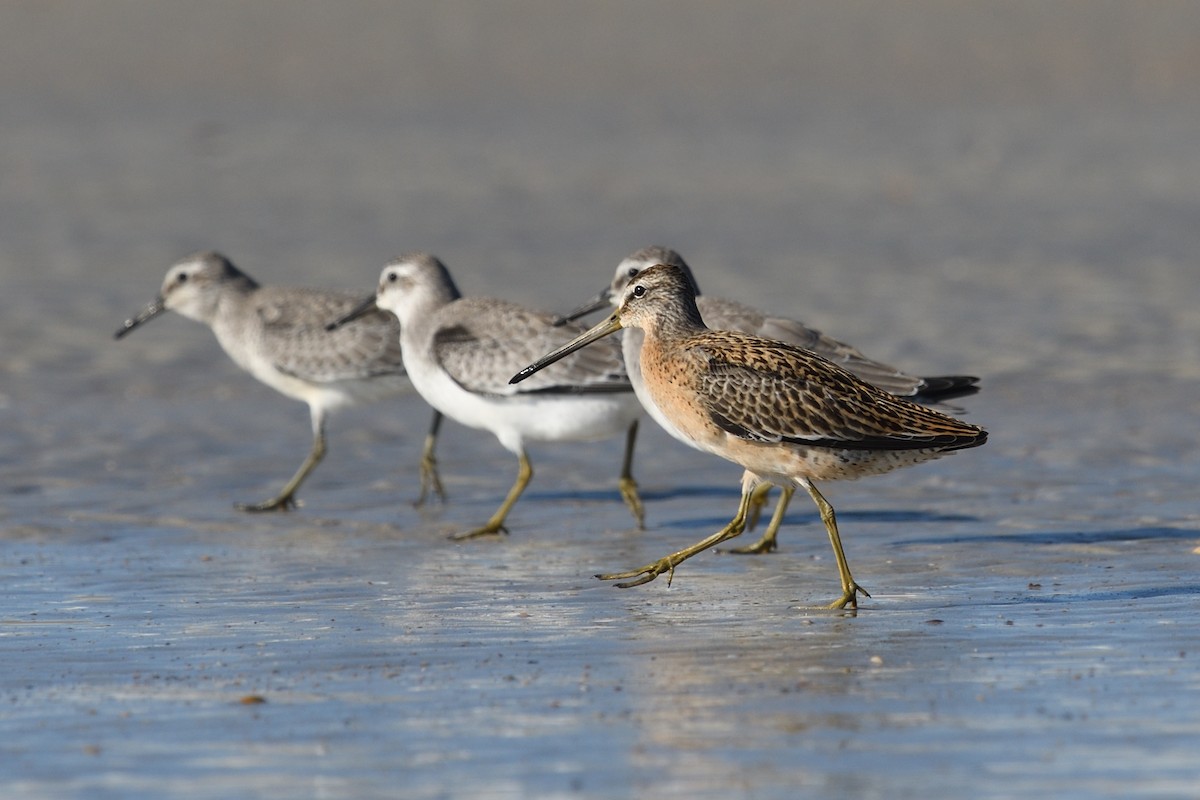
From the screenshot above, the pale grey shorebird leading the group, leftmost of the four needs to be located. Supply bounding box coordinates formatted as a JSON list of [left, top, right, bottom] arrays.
[[115, 252, 440, 511]]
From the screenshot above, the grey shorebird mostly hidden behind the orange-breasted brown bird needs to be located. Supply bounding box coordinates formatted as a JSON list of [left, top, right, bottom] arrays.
[[557, 245, 979, 553]]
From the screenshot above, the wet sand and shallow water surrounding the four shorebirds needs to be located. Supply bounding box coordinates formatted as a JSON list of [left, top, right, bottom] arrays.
[[0, 2, 1200, 798]]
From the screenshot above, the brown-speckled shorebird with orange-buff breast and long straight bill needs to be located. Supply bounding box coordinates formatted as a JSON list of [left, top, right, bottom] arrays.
[[511, 265, 988, 608]]
